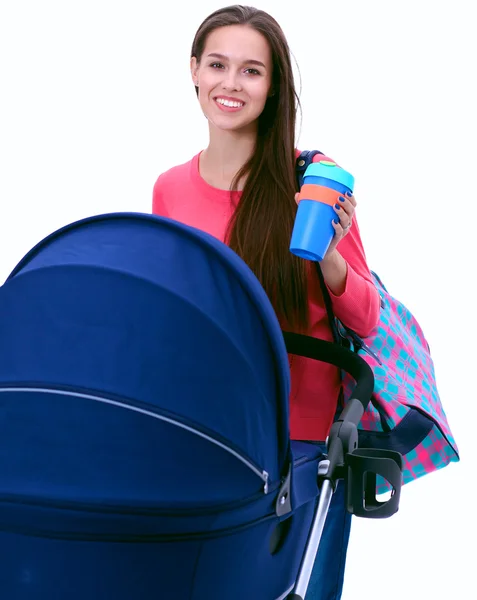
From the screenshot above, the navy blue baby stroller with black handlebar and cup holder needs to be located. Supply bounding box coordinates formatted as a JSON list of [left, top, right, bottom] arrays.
[[0, 213, 401, 600]]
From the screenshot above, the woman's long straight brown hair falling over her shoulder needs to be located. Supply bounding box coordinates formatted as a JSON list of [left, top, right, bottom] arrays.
[[191, 5, 308, 330]]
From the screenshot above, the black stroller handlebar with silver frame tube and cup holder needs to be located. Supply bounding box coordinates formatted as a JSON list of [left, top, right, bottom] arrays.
[[279, 333, 402, 600]]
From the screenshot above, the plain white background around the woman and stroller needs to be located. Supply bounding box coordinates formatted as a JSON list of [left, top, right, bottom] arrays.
[[0, 0, 477, 600]]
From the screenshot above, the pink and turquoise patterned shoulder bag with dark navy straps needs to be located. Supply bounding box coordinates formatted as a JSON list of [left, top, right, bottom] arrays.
[[297, 150, 459, 493]]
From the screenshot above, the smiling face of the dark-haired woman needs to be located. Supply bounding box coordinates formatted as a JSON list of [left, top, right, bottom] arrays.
[[191, 25, 273, 132]]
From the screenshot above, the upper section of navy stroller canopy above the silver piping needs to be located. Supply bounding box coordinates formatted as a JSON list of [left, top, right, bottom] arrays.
[[0, 214, 289, 496]]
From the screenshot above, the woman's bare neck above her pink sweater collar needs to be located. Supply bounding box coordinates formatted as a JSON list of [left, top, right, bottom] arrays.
[[199, 126, 257, 190]]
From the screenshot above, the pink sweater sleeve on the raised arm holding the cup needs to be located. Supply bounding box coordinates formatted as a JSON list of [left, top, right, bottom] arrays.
[[328, 214, 380, 337]]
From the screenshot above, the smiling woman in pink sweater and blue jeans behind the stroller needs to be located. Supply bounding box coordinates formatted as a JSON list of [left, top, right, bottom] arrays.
[[153, 6, 379, 600]]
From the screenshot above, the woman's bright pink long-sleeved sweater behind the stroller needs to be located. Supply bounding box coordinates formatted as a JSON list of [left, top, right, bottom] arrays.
[[152, 154, 379, 440]]
